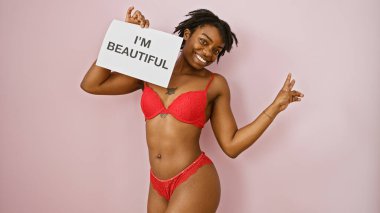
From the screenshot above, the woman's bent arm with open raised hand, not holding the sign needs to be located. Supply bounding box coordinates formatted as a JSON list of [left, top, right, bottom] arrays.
[[210, 74, 304, 158]]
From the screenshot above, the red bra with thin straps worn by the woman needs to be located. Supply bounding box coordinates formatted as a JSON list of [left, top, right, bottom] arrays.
[[140, 73, 214, 128]]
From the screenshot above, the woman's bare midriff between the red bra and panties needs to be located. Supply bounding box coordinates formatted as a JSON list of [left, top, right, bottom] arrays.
[[146, 114, 202, 180]]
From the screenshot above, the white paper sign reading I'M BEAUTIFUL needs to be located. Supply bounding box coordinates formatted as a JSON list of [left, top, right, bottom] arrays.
[[96, 20, 182, 88]]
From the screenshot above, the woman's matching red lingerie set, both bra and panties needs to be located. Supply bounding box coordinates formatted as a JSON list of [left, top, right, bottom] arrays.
[[141, 73, 214, 200]]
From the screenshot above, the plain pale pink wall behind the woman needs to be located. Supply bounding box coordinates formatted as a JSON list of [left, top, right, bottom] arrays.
[[0, 0, 380, 213]]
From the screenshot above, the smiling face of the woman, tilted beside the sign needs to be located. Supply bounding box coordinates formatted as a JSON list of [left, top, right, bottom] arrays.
[[182, 25, 224, 69]]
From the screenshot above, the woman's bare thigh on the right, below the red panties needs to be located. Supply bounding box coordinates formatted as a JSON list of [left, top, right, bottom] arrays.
[[166, 164, 220, 213]]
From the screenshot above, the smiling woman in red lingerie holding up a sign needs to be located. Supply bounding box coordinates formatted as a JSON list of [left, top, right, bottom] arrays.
[[81, 7, 303, 212]]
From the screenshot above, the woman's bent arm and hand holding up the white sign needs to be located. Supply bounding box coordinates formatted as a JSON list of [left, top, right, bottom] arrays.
[[80, 7, 149, 95]]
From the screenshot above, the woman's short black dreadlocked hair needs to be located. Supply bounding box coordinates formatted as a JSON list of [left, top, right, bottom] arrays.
[[173, 9, 238, 62]]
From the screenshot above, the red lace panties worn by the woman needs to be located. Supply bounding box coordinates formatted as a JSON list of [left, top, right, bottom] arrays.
[[150, 152, 212, 201]]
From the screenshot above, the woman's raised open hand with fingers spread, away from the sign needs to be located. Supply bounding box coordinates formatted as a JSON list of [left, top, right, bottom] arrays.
[[273, 73, 304, 112]]
